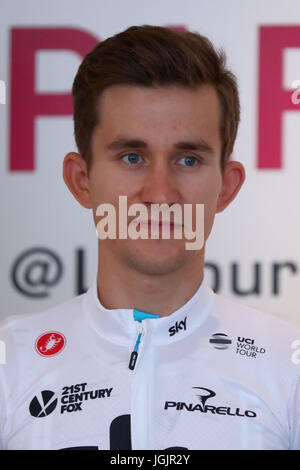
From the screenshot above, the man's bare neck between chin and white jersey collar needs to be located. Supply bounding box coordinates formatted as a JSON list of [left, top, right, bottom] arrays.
[[97, 247, 204, 317]]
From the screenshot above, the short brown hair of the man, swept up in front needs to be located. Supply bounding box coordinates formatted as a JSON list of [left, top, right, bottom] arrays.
[[72, 25, 240, 172]]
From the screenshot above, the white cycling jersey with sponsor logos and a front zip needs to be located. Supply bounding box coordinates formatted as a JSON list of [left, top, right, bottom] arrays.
[[0, 278, 300, 450]]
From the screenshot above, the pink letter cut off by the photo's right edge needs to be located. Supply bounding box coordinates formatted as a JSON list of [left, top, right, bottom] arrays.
[[257, 26, 300, 169]]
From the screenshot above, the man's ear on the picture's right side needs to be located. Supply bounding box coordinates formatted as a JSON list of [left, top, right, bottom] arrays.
[[216, 161, 246, 212]]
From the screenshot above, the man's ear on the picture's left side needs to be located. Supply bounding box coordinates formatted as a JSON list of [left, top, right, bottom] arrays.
[[63, 152, 93, 209]]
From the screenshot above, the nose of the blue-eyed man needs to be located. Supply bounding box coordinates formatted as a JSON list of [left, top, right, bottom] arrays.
[[141, 162, 180, 206]]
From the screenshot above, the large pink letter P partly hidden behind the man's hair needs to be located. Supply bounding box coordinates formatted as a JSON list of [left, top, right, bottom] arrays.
[[9, 27, 99, 171]]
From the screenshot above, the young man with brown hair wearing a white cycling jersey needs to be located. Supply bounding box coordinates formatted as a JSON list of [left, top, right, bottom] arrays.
[[0, 26, 300, 449]]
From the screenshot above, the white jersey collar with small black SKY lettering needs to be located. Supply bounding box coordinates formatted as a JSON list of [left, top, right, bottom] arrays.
[[82, 277, 215, 345]]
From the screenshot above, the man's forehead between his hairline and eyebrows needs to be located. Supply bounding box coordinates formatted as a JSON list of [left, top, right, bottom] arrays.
[[93, 85, 221, 151]]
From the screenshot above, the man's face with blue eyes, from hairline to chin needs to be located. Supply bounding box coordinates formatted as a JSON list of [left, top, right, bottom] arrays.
[[89, 85, 222, 274]]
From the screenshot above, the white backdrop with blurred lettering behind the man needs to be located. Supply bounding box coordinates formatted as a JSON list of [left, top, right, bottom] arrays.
[[0, 0, 300, 324]]
